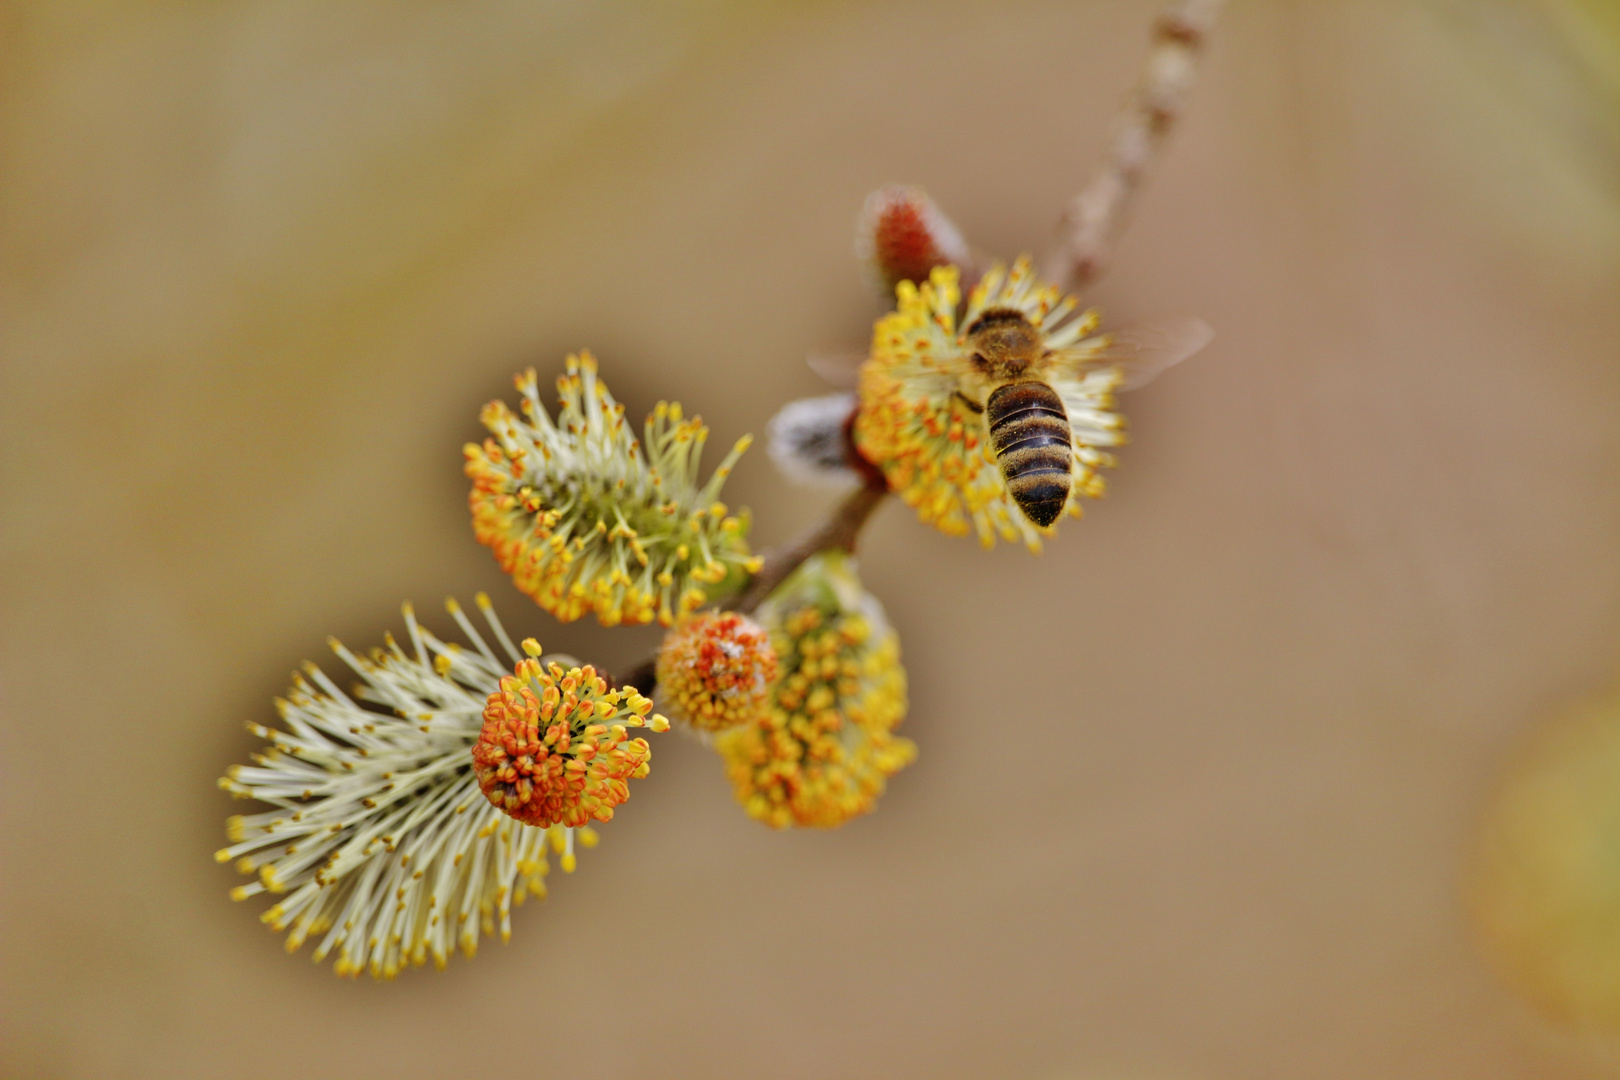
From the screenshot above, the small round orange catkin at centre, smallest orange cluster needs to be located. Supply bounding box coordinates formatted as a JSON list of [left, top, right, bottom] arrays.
[[658, 612, 776, 732]]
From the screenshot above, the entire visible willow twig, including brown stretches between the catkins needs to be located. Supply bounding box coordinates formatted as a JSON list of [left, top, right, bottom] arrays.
[[622, 0, 1225, 695]]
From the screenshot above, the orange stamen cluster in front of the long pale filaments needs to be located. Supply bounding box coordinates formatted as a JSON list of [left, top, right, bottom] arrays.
[[473, 641, 669, 827]]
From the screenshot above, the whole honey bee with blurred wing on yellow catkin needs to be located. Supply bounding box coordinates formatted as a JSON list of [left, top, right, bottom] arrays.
[[956, 308, 1213, 528]]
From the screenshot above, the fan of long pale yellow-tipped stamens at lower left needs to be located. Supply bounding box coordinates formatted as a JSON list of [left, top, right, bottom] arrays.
[[215, 594, 612, 978]]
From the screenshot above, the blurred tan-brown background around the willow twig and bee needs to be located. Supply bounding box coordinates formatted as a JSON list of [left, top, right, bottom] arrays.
[[0, 0, 1620, 1080]]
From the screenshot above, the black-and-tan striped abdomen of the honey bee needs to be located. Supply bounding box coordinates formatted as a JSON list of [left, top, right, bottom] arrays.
[[985, 382, 1074, 526]]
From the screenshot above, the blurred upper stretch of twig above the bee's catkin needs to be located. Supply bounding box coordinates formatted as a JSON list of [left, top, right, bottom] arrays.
[[1043, 0, 1225, 293]]
